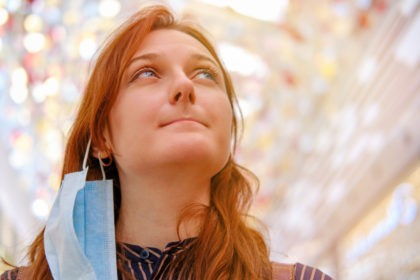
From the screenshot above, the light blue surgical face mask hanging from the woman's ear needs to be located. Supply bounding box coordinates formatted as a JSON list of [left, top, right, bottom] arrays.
[[44, 140, 117, 280]]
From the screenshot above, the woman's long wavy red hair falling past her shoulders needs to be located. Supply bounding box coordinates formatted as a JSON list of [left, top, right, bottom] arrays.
[[24, 6, 271, 280]]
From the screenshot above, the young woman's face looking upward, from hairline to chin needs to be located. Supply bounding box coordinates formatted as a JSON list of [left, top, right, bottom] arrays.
[[109, 29, 232, 177]]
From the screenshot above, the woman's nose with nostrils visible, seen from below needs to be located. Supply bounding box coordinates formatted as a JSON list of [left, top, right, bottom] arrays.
[[169, 74, 196, 105]]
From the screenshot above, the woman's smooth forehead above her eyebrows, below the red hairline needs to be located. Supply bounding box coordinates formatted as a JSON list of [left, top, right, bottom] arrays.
[[135, 29, 213, 57]]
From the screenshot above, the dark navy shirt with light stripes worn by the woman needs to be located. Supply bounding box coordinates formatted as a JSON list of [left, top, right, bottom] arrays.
[[0, 238, 332, 280]]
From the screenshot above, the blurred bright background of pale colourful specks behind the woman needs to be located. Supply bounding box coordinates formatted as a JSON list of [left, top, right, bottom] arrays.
[[0, 0, 420, 279]]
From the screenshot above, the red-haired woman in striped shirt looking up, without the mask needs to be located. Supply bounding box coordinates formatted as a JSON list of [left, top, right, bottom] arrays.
[[1, 6, 327, 279]]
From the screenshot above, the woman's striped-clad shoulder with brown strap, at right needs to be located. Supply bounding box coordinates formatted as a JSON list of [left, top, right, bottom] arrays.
[[271, 262, 332, 280]]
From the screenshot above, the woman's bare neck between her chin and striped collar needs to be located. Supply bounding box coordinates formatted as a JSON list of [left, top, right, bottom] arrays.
[[116, 173, 210, 249]]
